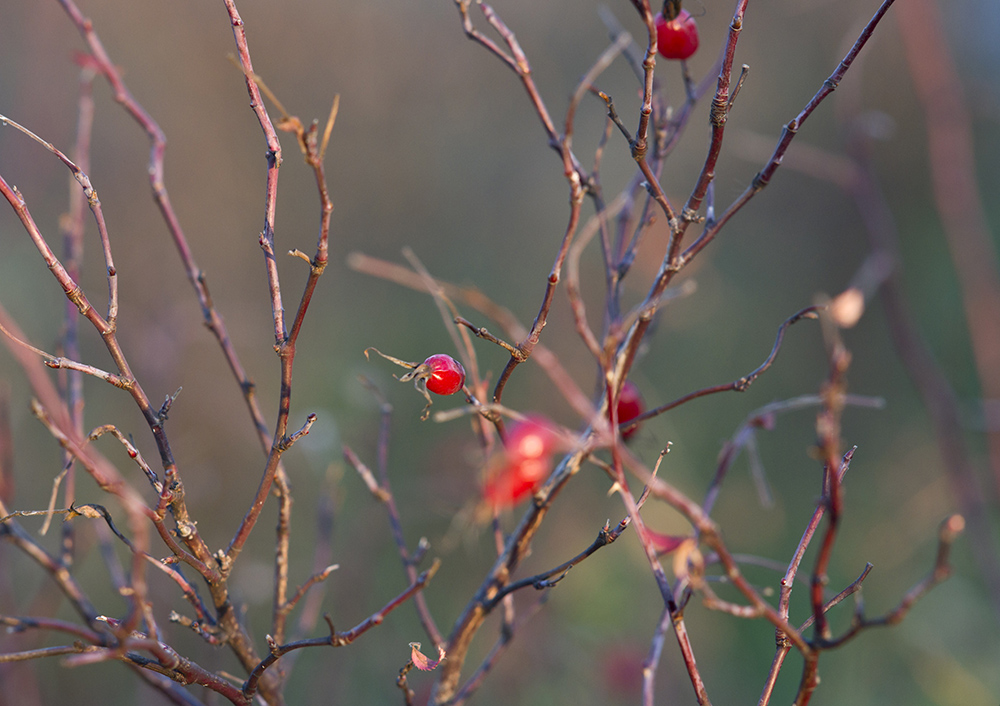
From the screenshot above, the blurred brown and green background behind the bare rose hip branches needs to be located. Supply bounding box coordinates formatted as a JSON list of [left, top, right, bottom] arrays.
[[0, 0, 1000, 706]]
